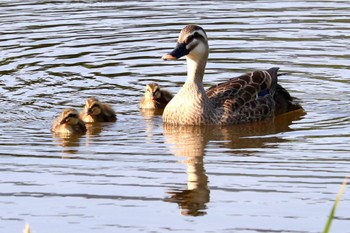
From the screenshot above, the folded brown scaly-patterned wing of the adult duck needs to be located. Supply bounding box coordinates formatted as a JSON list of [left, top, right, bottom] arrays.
[[207, 67, 279, 123]]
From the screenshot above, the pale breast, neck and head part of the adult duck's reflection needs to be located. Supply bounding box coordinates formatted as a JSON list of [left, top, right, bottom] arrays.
[[163, 125, 210, 216]]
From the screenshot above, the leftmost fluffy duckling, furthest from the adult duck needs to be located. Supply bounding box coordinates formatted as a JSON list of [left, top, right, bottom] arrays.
[[51, 108, 86, 135]]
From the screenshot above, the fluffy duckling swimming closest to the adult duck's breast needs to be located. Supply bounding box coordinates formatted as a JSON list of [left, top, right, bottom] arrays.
[[140, 83, 173, 109]]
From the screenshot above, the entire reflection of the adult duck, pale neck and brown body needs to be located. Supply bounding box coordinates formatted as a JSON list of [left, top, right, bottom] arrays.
[[163, 110, 305, 216]]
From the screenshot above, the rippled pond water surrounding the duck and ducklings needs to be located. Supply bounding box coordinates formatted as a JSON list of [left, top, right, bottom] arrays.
[[0, 0, 350, 233]]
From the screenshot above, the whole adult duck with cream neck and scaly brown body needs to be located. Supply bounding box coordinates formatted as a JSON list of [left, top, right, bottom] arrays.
[[163, 25, 301, 125]]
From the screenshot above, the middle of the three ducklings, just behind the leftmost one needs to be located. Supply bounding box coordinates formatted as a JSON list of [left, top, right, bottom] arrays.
[[80, 97, 117, 123]]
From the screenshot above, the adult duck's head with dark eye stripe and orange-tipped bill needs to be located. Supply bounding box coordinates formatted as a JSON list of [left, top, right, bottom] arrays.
[[162, 24, 209, 60]]
